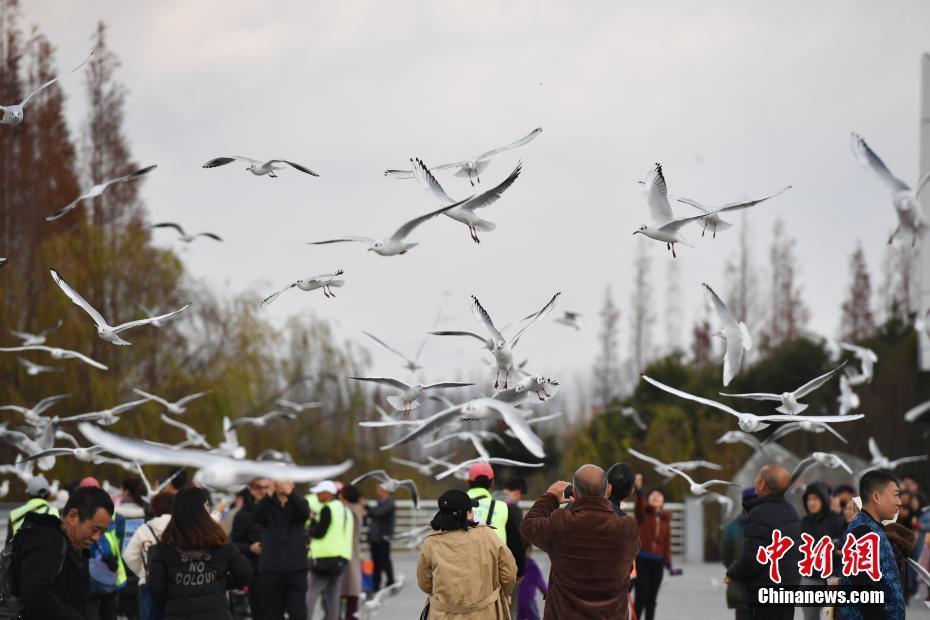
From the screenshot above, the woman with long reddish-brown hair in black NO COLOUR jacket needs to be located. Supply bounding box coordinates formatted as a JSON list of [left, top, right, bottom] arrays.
[[147, 487, 252, 620]]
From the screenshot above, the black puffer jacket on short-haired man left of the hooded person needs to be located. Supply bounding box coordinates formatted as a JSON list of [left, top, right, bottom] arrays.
[[727, 495, 801, 596]]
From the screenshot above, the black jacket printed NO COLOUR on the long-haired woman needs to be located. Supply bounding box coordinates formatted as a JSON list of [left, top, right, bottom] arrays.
[[146, 543, 252, 620]]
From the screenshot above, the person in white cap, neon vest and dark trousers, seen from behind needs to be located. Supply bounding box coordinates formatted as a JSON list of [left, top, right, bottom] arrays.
[[307, 480, 355, 620]]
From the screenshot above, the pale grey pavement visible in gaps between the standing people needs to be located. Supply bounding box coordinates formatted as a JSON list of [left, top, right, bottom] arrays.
[[364, 551, 930, 620]]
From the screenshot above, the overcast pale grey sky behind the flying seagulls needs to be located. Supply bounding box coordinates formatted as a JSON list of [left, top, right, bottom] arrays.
[[23, 0, 930, 392]]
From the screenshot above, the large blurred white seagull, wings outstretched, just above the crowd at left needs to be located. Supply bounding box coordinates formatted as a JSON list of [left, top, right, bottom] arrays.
[[78, 423, 352, 489]]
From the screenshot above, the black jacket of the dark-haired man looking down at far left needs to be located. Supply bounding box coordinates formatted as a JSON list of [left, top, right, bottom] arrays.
[[12, 513, 90, 620]]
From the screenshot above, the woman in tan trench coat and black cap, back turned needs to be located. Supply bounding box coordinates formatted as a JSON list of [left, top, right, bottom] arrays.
[[417, 489, 517, 620]]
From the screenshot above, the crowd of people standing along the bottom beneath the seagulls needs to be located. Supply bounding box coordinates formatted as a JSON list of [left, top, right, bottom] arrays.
[[0, 463, 930, 620]]
